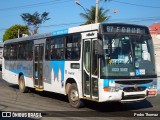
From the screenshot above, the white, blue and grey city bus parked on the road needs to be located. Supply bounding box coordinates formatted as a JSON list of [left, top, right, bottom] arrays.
[[2, 23, 157, 108]]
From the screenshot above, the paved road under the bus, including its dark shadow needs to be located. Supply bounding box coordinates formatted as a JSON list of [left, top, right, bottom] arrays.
[[0, 75, 160, 120]]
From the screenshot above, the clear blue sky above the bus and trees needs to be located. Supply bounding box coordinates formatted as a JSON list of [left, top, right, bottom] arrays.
[[0, 0, 160, 42]]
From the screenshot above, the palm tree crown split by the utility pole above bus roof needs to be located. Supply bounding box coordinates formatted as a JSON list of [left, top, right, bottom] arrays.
[[80, 6, 110, 25]]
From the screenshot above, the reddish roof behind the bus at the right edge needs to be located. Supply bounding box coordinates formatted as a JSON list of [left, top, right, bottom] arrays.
[[149, 23, 160, 34]]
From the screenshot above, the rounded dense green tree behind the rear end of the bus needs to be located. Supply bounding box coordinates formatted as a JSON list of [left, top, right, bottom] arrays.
[[3, 24, 29, 41]]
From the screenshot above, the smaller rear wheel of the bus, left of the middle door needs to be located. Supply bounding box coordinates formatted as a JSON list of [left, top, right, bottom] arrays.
[[19, 75, 28, 93]]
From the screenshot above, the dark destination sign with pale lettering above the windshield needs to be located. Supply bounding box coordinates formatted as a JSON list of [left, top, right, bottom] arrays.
[[103, 24, 148, 34]]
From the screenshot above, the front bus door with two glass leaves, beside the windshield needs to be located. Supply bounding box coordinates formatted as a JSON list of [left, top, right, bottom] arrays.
[[83, 39, 98, 99]]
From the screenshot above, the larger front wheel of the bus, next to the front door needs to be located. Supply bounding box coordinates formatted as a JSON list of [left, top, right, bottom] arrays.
[[68, 83, 84, 108]]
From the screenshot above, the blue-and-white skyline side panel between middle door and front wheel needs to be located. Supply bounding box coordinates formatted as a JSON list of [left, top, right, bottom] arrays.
[[43, 61, 65, 94]]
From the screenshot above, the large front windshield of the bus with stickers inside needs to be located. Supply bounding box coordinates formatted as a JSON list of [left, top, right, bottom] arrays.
[[100, 34, 155, 77]]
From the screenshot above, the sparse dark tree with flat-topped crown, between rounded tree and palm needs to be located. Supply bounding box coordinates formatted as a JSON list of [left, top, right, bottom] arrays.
[[20, 12, 50, 35]]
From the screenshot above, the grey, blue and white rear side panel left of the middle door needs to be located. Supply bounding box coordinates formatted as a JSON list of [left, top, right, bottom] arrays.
[[3, 61, 33, 87]]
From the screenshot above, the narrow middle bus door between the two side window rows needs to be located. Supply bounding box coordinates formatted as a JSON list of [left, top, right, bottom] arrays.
[[33, 40, 44, 90]]
